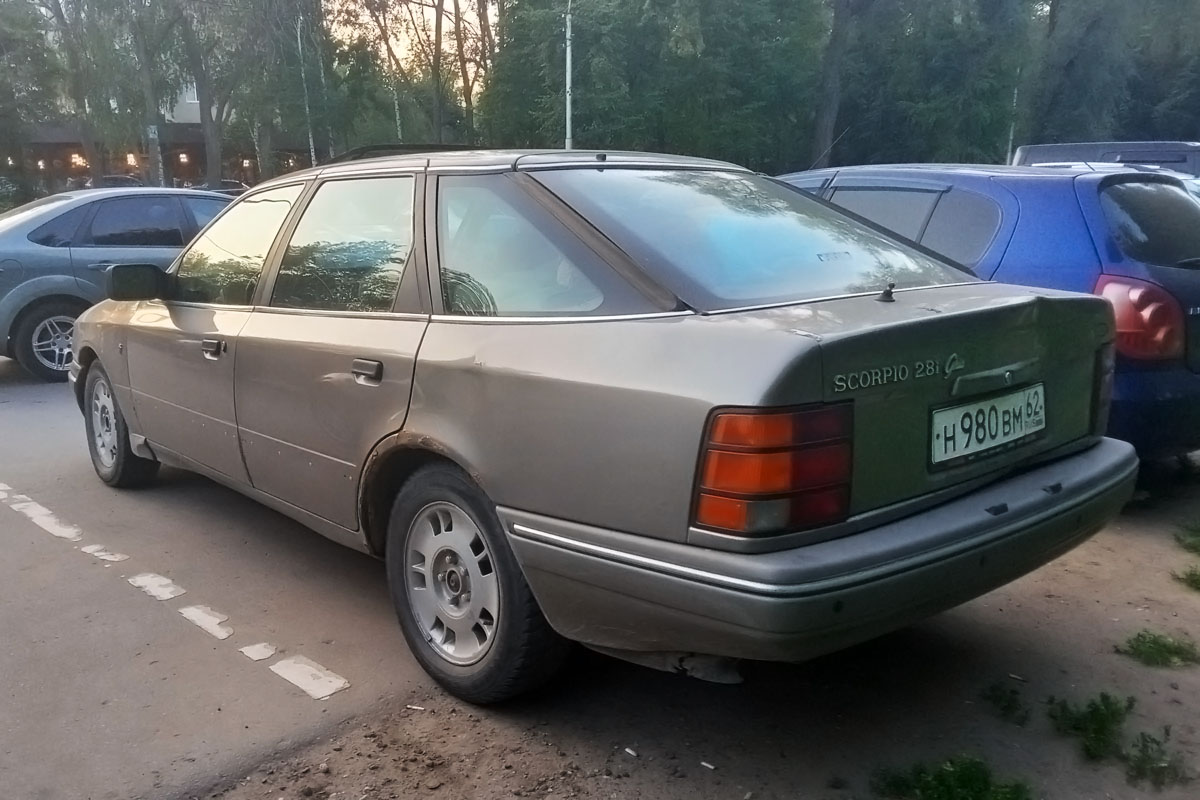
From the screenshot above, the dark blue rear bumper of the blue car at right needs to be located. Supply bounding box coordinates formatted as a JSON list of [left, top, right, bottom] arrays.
[[1108, 367, 1200, 458]]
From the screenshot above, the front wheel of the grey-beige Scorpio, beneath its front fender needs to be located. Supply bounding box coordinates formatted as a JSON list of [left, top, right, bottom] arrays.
[[83, 361, 158, 488]]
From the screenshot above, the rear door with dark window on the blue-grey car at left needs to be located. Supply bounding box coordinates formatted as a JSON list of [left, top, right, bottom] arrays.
[[71, 194, 191, 302]]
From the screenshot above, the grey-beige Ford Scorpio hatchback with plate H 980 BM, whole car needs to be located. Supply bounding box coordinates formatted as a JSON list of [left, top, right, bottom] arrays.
[[71, 151, 1138, 702]]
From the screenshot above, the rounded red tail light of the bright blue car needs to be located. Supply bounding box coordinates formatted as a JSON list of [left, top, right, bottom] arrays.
[[1096, 275, 1184, 361]]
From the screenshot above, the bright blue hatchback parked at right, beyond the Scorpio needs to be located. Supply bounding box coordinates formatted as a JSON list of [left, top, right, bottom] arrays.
[[781, 164, 1200, 458]]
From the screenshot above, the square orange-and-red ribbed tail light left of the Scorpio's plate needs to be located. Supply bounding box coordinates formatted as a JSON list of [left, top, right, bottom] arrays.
[[694, 403, 854, 536]]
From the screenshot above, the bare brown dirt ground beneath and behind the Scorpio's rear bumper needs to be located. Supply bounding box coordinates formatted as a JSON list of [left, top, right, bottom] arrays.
[[204, 473, 1200, 800]]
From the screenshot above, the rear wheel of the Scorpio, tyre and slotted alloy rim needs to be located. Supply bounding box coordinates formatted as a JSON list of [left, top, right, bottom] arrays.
[[386, 464, 570, 704]]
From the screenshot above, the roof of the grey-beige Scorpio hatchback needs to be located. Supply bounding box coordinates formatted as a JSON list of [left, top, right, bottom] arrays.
[[254, 150, 750, 191]]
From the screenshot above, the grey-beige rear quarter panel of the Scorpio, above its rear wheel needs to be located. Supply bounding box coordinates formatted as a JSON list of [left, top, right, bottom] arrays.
[[406, 314, 821, 541]]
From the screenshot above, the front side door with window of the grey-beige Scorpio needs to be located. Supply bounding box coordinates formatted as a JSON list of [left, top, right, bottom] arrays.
[[126, 184, 304, 483]]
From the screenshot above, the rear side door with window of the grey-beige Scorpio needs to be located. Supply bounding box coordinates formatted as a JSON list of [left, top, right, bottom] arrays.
[[235, 174, 428, 529]]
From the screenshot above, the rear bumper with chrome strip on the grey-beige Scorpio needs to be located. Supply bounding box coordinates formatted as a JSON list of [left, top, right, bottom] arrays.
[[500, 439, 1138, 661]]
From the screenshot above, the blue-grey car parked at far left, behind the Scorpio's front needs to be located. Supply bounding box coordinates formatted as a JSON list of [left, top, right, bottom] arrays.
[[0, 188, 229, 380]]
